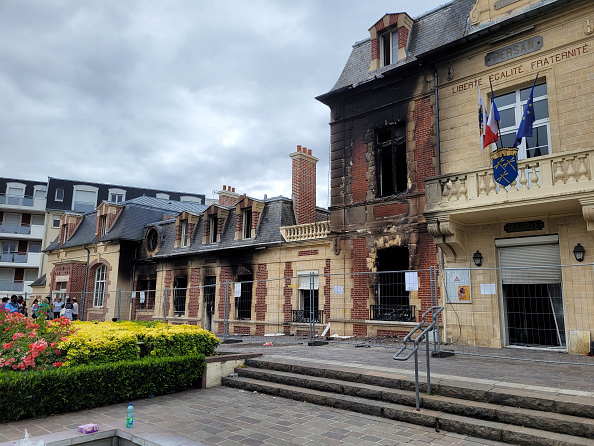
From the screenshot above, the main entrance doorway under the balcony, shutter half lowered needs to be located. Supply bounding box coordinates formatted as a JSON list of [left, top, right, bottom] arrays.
[[495, 235, 566, 347]]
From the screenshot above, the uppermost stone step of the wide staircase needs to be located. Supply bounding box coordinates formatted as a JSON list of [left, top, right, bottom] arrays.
[[245, 358, 594, 419]]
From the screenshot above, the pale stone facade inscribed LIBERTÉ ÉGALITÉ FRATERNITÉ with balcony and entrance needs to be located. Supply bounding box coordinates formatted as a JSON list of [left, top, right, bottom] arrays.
[[424, 0, 594, 353]]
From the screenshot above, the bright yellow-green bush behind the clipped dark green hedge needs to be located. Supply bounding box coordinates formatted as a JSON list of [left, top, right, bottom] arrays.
[[60, 321, 219, 365]]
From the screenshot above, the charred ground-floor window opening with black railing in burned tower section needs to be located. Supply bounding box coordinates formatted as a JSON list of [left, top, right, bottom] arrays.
[[371, 246, 415, 321]]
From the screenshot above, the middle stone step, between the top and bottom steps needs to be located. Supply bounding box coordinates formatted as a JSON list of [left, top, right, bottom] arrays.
[[235, 367, 594, 439]]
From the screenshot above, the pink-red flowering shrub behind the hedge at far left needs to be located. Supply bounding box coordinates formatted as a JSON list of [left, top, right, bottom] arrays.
[[0, 312, 75, 370]]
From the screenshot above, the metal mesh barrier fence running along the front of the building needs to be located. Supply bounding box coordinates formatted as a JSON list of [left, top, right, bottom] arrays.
[[16, 264, 594, 365]]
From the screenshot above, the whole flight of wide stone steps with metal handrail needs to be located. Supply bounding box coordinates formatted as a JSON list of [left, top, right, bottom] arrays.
[[223, 358, 594, 446]]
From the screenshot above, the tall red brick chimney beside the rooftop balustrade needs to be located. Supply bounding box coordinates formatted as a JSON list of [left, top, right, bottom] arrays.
[[289, 146, 318, 225]]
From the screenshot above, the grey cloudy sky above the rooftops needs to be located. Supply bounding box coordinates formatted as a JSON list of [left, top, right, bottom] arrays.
[[0, 0, 446, 207]]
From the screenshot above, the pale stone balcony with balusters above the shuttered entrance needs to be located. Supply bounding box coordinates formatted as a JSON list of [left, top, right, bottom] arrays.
[[425, 148, 594, 223]]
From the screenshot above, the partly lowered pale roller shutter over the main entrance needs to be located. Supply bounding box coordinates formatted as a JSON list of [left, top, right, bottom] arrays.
[[499, 239, 561, 284]]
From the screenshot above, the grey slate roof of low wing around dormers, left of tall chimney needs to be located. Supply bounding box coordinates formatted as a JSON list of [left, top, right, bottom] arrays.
[[143, 197, 329, 258]]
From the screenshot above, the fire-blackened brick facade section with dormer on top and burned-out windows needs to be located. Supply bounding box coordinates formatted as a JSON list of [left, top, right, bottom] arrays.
[[317, 13, 438, 336]]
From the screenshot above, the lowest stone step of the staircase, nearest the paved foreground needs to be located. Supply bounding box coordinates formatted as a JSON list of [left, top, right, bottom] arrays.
[[223, 376, 594, 446]]
